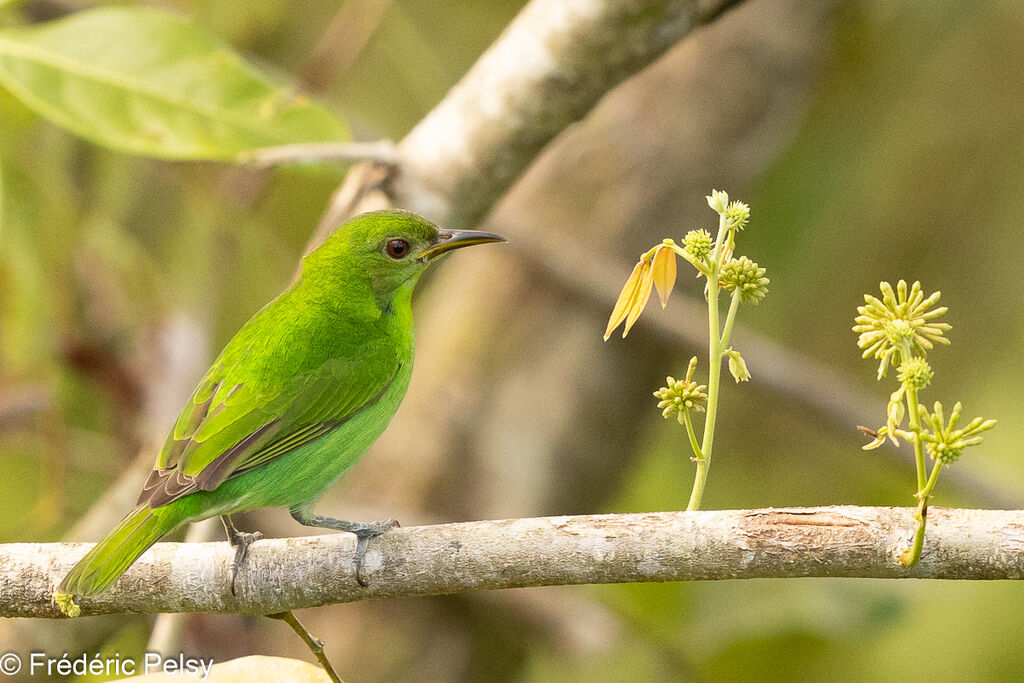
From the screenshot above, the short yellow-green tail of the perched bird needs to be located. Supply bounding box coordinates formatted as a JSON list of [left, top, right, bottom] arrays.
[[56, 504, 178, 595]]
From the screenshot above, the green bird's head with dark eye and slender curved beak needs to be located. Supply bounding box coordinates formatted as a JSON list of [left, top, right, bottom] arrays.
[[304, 209, 505, 299]]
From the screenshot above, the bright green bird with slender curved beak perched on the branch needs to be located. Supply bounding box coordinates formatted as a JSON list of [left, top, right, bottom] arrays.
[[56, 211, 504, 596]]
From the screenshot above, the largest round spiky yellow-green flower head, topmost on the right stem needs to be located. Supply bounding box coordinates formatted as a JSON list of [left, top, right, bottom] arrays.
[[853, 280, 950, 379]]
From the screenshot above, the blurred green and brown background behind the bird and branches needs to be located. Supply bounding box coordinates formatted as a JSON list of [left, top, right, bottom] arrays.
[[0, 0, 1024, 681]]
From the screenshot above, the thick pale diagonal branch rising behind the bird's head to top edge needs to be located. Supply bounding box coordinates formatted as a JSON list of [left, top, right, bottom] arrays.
[[393, 0, 736, 227]]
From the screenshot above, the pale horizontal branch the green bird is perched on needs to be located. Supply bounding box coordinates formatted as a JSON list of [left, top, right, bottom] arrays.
[[6, 506, 1024, 617]]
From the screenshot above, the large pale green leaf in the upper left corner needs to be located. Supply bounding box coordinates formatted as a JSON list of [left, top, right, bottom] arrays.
[[0, 7, 349, 160]]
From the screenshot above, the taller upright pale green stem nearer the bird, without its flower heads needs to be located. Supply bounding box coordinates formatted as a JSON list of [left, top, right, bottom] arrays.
[[686, 215, 736, 511]]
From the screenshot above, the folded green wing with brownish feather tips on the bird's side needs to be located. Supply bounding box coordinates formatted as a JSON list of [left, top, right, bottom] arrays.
[[138, 350, 400, 508]]
